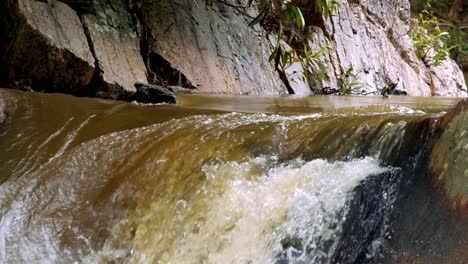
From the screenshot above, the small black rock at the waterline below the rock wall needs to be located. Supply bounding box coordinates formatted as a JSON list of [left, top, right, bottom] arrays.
[[133, 83, 176, 103]]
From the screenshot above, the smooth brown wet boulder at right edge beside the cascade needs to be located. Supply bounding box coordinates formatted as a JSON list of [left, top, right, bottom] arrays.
[[379, 99, 468, 264]]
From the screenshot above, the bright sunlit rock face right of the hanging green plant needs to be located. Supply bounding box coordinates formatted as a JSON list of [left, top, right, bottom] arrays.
[[316, 0, 468, 97]]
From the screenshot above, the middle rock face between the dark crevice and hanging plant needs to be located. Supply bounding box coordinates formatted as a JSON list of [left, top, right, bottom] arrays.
[[142, 0, 287, 94]]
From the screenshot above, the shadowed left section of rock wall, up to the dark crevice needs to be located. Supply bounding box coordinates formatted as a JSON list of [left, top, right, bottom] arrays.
[[0, 0, 154, 100]]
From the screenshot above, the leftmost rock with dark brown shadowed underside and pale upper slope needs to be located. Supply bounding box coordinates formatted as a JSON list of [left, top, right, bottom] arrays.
[[0, 0, 94, 93]]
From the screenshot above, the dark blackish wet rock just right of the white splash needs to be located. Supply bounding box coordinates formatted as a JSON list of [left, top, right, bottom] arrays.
[[331, 169, 401, 264]]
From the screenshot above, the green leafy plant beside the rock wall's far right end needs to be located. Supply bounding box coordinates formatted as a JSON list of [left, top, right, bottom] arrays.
[[410, 2, 453, 66]]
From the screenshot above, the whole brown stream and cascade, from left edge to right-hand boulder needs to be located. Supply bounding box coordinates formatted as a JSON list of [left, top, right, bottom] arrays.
[[0, 89, 466, 263]]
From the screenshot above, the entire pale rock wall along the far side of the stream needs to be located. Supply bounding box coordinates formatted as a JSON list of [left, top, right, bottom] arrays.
[[0, 0, 468, 98]]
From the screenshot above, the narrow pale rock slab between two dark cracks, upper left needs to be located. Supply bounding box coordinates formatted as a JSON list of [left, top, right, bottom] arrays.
[[82, 0, 147, 100]]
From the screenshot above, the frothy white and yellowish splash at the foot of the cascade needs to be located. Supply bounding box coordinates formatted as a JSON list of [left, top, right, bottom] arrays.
[[88, 157, 387, 263]]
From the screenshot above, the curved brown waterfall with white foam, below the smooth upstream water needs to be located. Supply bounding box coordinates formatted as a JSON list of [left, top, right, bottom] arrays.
[[0, 102, 432, 263]]
